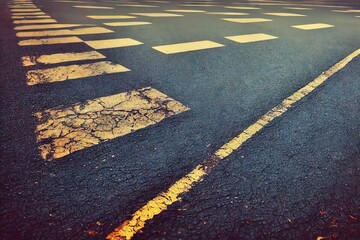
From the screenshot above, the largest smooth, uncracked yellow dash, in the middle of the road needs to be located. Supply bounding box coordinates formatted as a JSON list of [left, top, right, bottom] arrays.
[[153, 40, 224, 54]]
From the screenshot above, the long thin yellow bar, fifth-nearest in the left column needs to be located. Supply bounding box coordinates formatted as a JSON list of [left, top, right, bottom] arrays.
[[16, 27, 113, 37]]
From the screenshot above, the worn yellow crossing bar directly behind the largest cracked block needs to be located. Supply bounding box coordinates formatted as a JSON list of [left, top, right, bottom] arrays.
[[26, 61, 130, 85]]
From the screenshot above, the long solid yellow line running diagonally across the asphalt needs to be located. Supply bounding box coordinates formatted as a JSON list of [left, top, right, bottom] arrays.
[[106, 49, 360, 240]]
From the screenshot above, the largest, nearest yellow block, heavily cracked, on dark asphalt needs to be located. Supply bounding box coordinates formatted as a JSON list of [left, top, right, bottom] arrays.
[[35, 87, 190, 161]]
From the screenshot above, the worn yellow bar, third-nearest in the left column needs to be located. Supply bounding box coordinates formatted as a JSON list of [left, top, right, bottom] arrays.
[[22, 51, 106, 67]]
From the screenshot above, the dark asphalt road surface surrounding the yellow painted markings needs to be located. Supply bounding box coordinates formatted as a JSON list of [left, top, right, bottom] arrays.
[[0, 0, 360, 240]]
